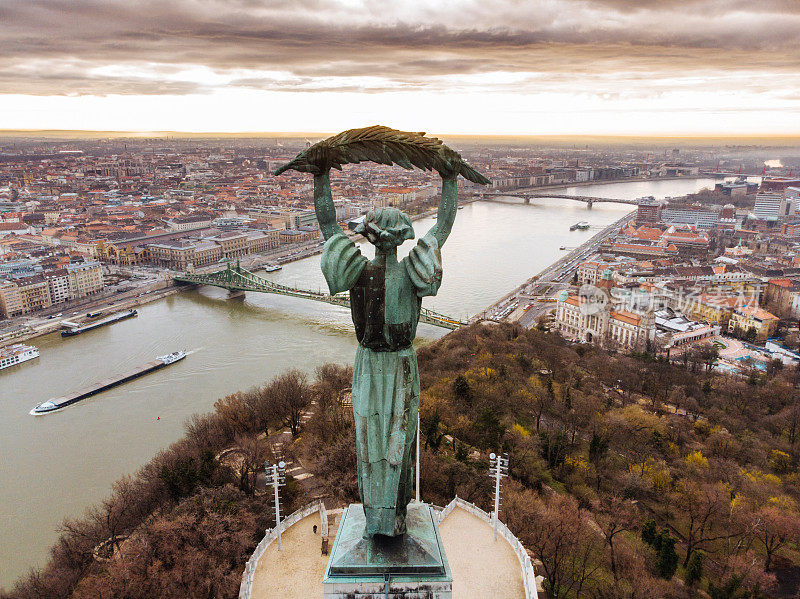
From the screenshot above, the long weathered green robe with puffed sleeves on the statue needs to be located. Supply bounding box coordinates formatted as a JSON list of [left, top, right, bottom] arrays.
[[322, 233, 442, 536]]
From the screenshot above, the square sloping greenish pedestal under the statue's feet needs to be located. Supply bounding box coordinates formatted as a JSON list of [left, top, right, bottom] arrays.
[[323, 503, 453, 599]]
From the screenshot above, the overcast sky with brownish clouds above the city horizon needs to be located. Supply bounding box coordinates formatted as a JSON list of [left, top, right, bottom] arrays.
[[0, 0, 800, 135]]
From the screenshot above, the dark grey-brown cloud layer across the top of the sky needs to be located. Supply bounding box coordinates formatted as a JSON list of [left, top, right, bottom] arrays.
[[0, 0, 800, 94]]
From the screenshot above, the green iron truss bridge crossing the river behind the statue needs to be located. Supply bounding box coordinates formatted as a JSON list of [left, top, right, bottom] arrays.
[[173, 260, 468, 330]]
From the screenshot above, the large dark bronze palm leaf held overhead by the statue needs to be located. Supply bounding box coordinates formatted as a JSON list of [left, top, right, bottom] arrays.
[[275, 125, 491, 185]]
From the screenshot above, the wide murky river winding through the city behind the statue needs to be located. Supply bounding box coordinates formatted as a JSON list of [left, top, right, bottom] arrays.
[[0, 179, 713, 587]]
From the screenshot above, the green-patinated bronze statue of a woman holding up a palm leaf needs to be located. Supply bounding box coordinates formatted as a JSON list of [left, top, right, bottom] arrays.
[[275, 126, 489, 537]]
